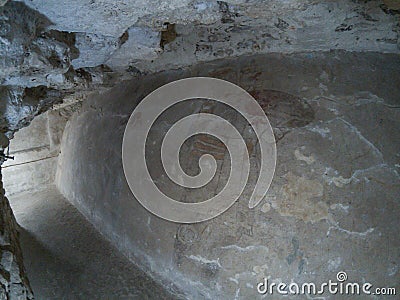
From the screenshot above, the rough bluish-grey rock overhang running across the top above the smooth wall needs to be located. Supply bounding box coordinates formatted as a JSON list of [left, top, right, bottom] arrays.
[[0, 0, 399, 98]]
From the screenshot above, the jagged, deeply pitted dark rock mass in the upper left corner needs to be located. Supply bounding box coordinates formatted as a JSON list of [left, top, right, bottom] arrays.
[[0, 2, 111, 138]]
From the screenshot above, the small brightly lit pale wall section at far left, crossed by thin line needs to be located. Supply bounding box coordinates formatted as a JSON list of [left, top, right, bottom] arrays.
[[2, 102, 80, 197]]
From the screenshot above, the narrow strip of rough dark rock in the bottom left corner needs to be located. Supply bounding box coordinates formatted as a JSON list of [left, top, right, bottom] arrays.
[[0, 173, 33, 300]]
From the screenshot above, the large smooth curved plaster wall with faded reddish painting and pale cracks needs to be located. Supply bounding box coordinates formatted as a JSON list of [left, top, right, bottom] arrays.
[[57, 51, 400, 299]]
